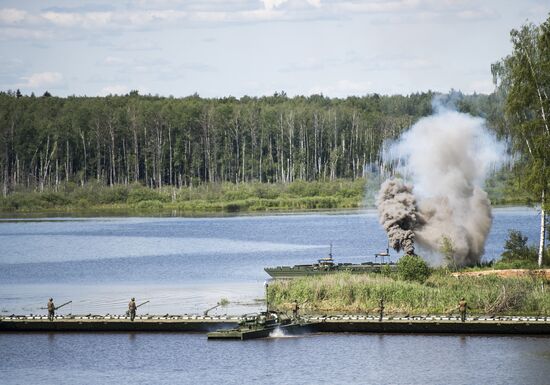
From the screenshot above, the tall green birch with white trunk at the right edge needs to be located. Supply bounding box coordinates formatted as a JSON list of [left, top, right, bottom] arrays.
[[491, 17, 550, 266]]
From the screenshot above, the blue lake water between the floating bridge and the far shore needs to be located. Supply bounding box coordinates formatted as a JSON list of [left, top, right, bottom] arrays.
[[0, 208, 539, 314]]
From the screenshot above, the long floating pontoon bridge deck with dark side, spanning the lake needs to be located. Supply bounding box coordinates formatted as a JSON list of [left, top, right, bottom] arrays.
[[0, 315, 550, 335]]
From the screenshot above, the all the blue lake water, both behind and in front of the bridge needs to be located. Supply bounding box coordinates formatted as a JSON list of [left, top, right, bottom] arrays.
[[0, 208, 550, 385]]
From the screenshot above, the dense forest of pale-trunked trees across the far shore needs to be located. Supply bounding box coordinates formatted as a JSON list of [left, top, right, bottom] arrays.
[[0, 91, 506, 196]]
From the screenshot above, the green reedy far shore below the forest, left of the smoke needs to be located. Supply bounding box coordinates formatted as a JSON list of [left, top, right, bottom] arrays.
[[0, 179, 365, 213]]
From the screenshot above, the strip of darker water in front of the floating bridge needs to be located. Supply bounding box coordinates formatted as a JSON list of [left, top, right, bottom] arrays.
[[0, 334, 550, 385]]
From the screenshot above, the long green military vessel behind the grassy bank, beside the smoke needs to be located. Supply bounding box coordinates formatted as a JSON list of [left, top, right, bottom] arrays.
[[264, 245, 397, 279]]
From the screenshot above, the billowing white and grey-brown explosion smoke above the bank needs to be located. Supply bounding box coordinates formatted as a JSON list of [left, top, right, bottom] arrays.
[[377, 105, 505, 265]]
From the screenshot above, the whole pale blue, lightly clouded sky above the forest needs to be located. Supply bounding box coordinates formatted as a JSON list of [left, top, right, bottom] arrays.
[[0, 0, 550, 98]]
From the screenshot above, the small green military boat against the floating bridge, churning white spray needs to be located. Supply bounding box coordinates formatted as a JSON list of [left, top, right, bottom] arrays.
[[207, 311, 308, 340]]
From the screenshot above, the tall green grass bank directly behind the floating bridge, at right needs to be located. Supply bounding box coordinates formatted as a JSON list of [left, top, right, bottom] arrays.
[[269, 272, 550, 316]]
